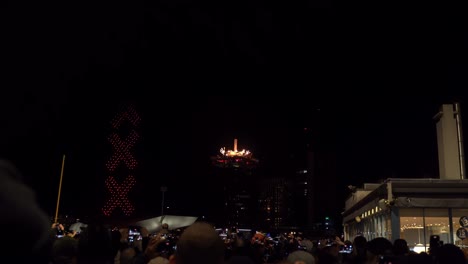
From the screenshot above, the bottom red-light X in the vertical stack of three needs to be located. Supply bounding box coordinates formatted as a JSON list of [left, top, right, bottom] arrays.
[[102, 175, 136, 216]]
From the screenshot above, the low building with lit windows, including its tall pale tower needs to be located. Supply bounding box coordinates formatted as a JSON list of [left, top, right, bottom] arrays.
[[343, 103, 468, 252]]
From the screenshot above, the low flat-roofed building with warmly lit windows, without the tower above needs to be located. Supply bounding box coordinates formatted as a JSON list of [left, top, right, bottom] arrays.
[[343, 179, 468, 252]]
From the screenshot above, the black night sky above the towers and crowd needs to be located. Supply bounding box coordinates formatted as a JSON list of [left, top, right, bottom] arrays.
[[0, 7, 468, 222]]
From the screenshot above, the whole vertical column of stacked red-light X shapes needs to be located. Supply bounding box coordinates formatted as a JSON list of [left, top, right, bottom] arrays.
[[102, 106, 141, 216]]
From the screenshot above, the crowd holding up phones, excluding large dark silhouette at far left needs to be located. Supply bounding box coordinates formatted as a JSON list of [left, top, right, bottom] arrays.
[[24, 222, 467, 264]]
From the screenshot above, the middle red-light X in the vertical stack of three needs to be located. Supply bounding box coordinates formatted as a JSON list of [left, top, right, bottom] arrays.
[[106, 130, 139, 172]]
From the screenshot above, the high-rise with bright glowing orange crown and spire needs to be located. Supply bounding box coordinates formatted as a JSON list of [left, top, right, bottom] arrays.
[[211, 139, 258, 227]]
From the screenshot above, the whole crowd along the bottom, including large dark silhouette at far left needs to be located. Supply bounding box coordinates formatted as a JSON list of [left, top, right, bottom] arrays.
[[0, 161, 467, 264]]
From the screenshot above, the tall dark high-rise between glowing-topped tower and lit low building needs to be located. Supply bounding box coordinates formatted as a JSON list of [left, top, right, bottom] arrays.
[[289, 113, 340, 230]]
